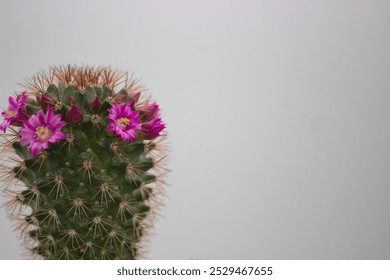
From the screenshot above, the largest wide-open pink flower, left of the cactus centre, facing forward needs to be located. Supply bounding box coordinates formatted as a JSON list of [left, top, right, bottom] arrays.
[[19, 107, 67, 157]]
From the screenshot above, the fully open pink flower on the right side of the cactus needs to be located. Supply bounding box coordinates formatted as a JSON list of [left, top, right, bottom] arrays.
[[107, 103, 141, 143]]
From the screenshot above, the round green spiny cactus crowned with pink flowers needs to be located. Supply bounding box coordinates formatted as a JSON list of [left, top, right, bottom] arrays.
[[0, 66, 167, 259]]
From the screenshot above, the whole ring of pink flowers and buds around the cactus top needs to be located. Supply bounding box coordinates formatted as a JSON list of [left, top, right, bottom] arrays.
[[0, 92, 165, 156]]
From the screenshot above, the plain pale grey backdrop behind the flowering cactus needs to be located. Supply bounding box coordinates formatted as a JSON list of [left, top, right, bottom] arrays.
[[0, 0, 390, 259]]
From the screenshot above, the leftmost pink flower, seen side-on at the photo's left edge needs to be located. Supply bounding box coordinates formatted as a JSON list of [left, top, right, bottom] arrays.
[[0, 92, 27, 132]]
